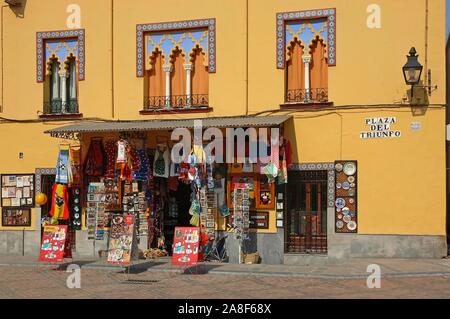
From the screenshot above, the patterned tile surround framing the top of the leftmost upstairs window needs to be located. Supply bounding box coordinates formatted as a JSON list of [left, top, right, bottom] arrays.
[[36, 29, 86, 83]]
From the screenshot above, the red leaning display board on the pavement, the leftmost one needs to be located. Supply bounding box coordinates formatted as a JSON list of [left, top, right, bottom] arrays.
[[39, 225, 74, 270]]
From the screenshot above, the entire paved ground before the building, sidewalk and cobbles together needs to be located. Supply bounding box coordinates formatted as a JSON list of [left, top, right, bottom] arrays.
[[0, 256, 450, 302]]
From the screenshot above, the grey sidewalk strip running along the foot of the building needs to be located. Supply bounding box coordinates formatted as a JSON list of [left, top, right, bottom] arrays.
[[0, 256, 450, 279]]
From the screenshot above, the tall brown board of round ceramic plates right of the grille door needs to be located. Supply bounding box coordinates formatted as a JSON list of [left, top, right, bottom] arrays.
[[334, 161, 358, 233]]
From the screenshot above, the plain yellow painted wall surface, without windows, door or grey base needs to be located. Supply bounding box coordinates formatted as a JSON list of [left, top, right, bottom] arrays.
[[0, 0, 446, 235]]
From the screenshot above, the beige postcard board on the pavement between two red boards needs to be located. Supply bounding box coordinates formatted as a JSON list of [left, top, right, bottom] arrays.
[[107, 214, 139, 281]]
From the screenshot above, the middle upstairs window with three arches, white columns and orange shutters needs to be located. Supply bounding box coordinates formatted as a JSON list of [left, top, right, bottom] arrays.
[[143, 24, 216, 114]]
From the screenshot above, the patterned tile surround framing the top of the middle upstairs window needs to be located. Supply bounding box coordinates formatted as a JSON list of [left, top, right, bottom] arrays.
[[136, 18, 216, 77]]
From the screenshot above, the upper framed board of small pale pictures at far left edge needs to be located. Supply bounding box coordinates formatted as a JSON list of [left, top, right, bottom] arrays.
[[1, 174, 34, 208]]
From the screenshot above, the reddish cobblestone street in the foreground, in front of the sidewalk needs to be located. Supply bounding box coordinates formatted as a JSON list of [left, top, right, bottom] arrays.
[[0, 266, 450, 299]]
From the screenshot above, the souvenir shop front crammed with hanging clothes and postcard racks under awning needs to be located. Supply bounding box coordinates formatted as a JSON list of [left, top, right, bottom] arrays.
[[44, 117, 292, 262]]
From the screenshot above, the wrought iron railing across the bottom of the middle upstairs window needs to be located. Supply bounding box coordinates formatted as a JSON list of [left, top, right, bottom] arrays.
[[144, 94, 209, 110]]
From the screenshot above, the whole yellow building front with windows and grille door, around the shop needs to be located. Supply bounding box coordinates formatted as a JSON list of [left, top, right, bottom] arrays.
[[0, 0, 447, 263]]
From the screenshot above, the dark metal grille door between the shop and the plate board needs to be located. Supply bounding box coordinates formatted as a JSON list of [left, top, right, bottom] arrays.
[[285, 171, 328, 254]]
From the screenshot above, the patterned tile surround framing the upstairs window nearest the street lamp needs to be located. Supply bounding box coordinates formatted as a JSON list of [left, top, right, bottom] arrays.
[[276, 8, 336, 69]]
